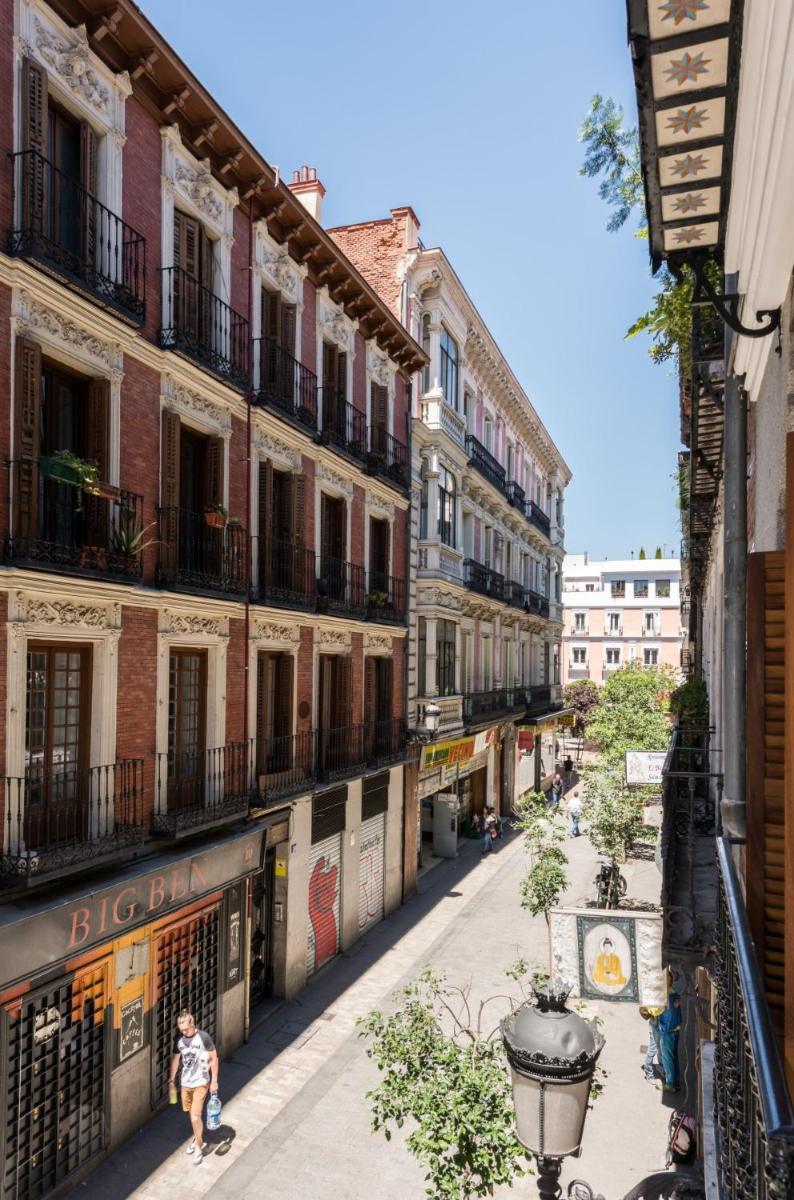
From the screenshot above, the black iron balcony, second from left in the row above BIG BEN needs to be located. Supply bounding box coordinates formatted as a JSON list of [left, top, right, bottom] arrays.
[[152, 742, 252, 838]]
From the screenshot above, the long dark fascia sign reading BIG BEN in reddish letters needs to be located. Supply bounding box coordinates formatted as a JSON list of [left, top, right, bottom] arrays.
[[0, 828, 265, 983]]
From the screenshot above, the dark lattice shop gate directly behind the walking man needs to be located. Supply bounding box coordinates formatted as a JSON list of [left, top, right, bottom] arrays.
[[152, 904, 219, 1103]]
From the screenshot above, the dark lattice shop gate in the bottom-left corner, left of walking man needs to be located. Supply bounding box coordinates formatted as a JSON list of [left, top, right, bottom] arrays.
[[2, 964, 108, 1200]]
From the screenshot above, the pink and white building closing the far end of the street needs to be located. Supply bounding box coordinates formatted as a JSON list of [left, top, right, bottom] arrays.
[[563, 553, 681, 684]]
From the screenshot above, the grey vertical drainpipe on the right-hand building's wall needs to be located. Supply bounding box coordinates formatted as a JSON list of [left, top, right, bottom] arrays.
[[721, 284, 747, 839]]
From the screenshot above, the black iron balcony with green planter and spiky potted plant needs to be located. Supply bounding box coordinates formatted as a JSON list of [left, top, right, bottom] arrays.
[[5, 458, 146, 582]]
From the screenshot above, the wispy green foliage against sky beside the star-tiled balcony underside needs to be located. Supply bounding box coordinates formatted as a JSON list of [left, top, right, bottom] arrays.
[[578, 95, 645, 233]]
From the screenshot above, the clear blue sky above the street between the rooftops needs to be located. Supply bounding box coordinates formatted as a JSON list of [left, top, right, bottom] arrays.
[[142, 0, 679, 557]]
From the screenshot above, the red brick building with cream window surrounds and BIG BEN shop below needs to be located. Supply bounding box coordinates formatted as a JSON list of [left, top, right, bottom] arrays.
[[0, 0, 425, 1185]]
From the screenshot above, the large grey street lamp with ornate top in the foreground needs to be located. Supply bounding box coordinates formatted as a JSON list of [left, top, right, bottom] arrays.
[[501, 978, 604, 1200]]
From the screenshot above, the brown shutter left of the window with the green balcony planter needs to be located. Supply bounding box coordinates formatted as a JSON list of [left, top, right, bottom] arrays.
[[13, 337, 41, 538]]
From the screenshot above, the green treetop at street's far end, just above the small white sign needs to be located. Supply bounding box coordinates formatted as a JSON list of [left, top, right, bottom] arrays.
[[588, 662, 672, 764]]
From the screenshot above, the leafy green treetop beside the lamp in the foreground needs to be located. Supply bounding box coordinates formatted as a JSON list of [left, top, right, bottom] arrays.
[[359, 970, 531, 1200]]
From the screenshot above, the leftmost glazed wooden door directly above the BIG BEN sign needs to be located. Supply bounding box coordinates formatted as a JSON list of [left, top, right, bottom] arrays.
[[24, 642, 91, 850]]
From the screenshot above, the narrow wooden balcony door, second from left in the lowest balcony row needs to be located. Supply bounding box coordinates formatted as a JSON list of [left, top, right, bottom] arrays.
[[168, 649, 206, 812]]
